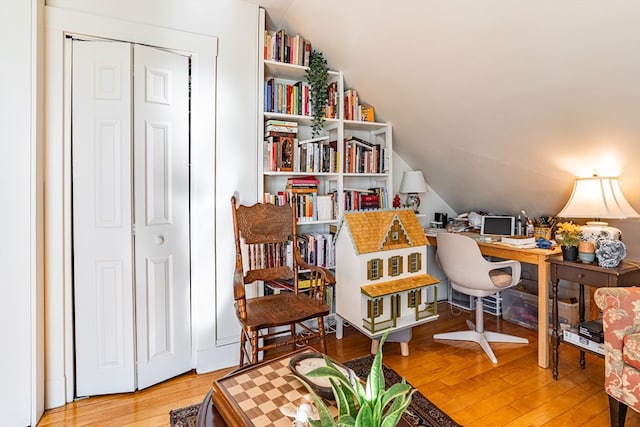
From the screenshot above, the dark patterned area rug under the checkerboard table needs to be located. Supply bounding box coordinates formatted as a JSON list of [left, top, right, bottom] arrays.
[[169, 355, 461, 427]]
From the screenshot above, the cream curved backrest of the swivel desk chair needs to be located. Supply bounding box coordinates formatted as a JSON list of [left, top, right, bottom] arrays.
[[436, 233, 520, 290]]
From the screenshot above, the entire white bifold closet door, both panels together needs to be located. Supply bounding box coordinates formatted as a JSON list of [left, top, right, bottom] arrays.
[[71, 40, 191, 396]]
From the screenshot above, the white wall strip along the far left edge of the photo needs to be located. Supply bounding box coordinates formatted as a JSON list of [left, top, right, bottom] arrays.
[[0, 0, 44, 426]]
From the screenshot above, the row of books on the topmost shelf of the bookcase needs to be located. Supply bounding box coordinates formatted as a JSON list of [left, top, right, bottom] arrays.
[[263, 29, 311, 67]]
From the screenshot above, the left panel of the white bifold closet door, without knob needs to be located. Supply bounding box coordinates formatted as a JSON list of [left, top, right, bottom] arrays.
[[72, 41, 135, 396]]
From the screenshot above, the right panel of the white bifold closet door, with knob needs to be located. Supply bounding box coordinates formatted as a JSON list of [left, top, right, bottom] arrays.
[[133, 45, 191, 388]]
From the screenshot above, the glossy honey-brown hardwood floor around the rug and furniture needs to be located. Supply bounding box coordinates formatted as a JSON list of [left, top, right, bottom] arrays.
[[38, 303, 640, 427]]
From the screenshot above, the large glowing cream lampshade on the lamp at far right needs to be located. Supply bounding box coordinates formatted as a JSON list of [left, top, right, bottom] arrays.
[[558, 176, 640, 219]]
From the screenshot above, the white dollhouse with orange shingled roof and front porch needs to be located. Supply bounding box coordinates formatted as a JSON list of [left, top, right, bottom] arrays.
[[335, 209, 438, 339]]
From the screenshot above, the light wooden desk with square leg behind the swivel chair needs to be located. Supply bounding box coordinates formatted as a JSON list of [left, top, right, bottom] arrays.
[[427, 233, 561, 368]]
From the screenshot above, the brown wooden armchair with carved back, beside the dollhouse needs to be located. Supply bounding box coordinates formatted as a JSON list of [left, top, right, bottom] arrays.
[[231, 196, 335, 367]]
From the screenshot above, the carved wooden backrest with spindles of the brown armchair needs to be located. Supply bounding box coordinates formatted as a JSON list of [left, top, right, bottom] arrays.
[[231, 196, 298, 301]]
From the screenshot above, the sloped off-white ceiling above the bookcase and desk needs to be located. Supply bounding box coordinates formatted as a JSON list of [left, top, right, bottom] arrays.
[[248, 0, 640, 221]]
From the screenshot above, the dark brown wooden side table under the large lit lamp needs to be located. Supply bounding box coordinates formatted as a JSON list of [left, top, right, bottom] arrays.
[[549, 257, 640, 379]]
